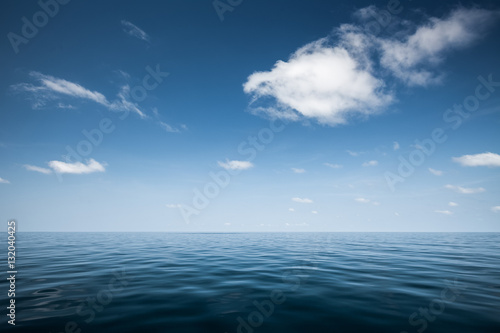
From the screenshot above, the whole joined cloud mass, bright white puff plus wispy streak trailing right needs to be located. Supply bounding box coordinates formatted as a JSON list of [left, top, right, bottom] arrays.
[[243, 7, 499, 126]]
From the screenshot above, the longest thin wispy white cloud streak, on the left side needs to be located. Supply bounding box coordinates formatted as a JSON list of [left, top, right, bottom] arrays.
[[11, 72, 146, 118]]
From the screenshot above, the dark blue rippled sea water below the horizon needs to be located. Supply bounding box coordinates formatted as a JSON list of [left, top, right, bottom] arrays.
[[0, 233, 500, 333]]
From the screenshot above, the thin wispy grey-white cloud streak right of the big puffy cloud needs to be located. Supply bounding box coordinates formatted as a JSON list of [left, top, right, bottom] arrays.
[[377, 7, 499, 86]]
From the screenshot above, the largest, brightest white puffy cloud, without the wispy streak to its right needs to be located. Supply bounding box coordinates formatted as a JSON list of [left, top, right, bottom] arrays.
[[243, 38, 393, 126]]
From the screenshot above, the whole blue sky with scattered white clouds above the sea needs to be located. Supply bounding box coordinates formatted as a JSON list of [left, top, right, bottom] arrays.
[[0, 0, 500, 232]]
